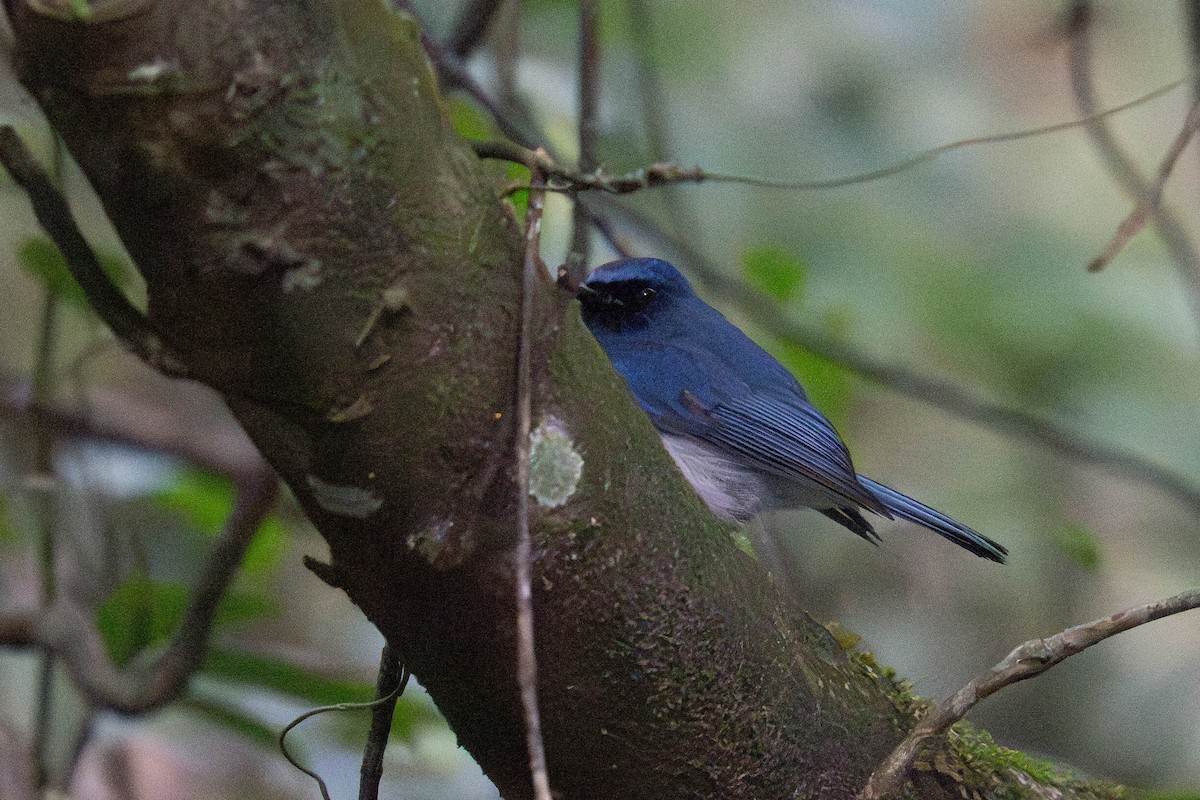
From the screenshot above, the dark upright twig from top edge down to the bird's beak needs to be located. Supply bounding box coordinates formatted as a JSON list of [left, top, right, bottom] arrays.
[[564, 0, 600, 290]]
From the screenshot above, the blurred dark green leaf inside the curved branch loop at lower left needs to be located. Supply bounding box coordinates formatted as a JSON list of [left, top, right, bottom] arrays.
[[96, 575, 187, 667]]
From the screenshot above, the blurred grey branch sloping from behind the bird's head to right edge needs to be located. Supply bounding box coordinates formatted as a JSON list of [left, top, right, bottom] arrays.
[[596, 197, 1200, 516]]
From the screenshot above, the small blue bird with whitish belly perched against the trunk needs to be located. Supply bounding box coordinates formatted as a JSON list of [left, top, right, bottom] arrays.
[[577, 258, 1008, 563]]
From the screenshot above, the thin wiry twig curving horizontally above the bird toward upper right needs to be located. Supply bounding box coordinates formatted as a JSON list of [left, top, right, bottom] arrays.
[[472, 74, 1184, 194]]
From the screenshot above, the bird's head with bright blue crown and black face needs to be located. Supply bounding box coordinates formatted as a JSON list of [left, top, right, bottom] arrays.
[[576, 258, 692, 338]]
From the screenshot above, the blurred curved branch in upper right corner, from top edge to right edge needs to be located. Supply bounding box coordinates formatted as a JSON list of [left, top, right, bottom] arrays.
[[1067, 0, 1200, 325]]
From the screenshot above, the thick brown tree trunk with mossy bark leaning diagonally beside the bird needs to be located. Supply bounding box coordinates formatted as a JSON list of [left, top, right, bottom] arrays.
[[0, 0, 1123, 800]]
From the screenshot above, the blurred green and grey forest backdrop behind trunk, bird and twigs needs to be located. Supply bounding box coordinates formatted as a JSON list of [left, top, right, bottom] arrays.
[[0, 0, 1200, 800]]
